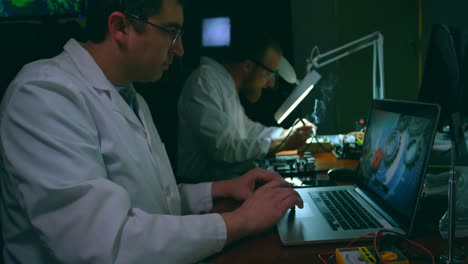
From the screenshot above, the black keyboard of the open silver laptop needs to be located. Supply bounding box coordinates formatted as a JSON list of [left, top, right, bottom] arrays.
[[309, 190, 383, 230]]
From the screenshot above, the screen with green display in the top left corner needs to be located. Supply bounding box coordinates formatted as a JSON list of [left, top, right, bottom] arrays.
[[0, 0, 84, 20]]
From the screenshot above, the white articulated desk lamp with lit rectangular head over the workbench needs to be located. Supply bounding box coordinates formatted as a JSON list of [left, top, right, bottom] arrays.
[[275, 31, 384, 124]]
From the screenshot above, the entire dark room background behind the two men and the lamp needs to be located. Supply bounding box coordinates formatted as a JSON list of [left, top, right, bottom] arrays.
[[0, 0, 468, 170]]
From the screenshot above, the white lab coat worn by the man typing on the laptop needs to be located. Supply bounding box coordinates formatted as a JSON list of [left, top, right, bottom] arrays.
[[0, 40, 226, 264]]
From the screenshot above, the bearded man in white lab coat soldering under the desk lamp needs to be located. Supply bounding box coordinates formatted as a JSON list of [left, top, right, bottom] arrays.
[[177, 29, 315, 183]]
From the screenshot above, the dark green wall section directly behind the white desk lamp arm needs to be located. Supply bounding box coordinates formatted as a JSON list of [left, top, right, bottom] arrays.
[[292, 0, 418, 133]]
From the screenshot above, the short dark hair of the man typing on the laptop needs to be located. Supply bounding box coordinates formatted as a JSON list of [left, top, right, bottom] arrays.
[[85, 0, 183, 43]]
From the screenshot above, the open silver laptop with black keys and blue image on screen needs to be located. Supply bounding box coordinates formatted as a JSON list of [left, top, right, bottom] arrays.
[[277, 100, 440, 245]]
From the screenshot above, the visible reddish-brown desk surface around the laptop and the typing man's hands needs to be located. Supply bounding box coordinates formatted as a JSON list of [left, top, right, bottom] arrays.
[[206, 152, 468, 264]]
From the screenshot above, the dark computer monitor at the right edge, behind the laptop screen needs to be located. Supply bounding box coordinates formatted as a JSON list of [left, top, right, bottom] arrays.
[[418, 24, 468, 161]]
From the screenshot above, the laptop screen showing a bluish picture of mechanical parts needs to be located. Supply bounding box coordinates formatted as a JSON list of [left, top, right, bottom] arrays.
[[358, 100, 439, 228]]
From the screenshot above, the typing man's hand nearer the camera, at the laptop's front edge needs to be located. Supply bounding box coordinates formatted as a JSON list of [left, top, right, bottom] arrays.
[[221, 180, 304, 243]]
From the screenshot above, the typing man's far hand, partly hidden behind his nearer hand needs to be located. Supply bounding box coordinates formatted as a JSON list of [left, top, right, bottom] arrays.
[[211, 168, 282, 201]]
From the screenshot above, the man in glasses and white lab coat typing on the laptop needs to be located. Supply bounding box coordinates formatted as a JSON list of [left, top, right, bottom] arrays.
[[0, 0, 302, 263]]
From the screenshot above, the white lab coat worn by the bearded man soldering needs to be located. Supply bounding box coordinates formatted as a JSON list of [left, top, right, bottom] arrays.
[[177, 57, 283, 182]]
